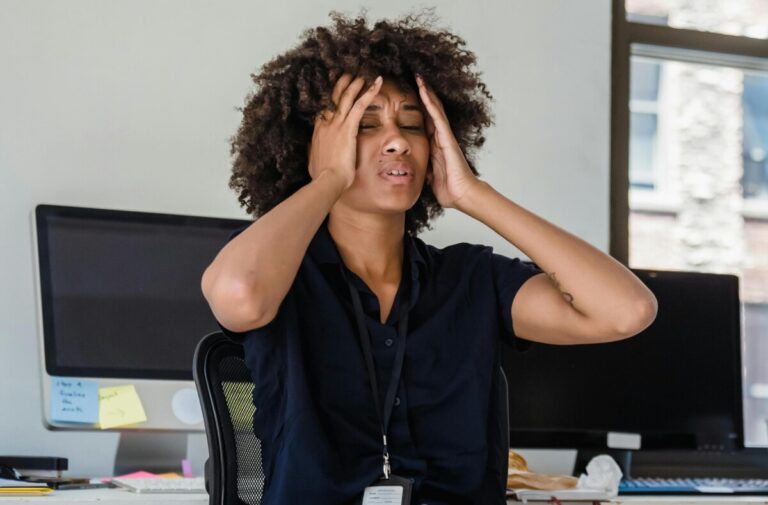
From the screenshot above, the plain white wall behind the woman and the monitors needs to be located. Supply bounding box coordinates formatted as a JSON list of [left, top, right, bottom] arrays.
[[0, 0, 610, 475]]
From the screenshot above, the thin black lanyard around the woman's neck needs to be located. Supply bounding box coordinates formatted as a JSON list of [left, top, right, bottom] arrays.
[[347, 278, 408, 479]]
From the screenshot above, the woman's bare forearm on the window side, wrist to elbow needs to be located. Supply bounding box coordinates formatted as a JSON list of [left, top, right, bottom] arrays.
[[457, 182, 656, 334]]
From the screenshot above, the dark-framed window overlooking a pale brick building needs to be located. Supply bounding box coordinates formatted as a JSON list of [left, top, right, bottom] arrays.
[[611, 0, 768, 447]]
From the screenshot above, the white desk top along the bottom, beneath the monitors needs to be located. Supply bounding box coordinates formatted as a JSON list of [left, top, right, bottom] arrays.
[[0, 489, 768, 505]]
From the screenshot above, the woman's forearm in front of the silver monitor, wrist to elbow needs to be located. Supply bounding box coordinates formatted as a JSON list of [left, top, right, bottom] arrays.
[[202, 171, 345, 331]]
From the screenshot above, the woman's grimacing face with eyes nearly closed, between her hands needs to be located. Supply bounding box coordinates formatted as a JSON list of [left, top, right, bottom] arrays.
[[340, 79, 429, 213]]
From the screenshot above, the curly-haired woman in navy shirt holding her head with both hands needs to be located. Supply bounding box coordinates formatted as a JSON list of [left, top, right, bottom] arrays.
[[202, 14, 656, 505]]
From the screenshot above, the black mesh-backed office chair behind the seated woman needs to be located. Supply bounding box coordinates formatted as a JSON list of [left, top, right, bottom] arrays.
[[192, 332, 509, 505]]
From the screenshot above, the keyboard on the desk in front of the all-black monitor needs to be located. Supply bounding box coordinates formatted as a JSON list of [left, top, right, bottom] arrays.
[[619, 478, 768, 495]]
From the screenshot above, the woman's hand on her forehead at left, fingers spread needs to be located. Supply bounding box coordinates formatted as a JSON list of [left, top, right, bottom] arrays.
[[309, 73, 383, 189]]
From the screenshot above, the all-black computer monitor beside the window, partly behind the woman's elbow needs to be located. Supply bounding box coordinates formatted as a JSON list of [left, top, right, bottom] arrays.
[[502, 270, 743, 449]]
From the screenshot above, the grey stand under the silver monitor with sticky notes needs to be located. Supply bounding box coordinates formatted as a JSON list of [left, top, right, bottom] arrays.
[[113, 432, 188, 475]]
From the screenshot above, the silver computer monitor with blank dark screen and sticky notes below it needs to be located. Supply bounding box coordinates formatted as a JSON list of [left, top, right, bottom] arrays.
[[33, 205, 249, 466]]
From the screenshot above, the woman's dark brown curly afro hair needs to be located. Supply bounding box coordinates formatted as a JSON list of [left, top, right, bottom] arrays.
[[229, 9, 493, 235]]
